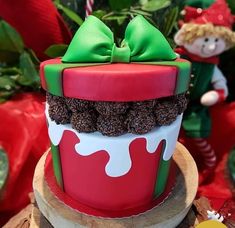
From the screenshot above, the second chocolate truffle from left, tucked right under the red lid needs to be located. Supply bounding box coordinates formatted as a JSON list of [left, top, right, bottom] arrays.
[[65, 98, 92, 112]]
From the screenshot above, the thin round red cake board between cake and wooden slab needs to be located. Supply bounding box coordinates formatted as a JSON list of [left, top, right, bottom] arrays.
[[44, 151, 176, 218]]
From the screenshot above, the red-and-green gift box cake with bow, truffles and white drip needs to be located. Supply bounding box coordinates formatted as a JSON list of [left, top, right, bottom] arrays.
[[40, 16, 190, 217]]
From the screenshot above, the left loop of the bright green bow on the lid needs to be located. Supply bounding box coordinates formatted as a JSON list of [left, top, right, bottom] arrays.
[[62, 16, 114, 63]]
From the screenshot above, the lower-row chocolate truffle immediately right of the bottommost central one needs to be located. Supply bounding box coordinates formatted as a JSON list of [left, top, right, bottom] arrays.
[[125, 110, 156, 134]]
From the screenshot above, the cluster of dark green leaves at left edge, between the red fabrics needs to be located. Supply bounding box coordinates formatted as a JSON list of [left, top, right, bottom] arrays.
[[0, 20, 40, 103]]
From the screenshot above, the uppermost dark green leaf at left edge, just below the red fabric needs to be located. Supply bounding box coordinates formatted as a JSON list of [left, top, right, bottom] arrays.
[[0, 21, 24, 53]]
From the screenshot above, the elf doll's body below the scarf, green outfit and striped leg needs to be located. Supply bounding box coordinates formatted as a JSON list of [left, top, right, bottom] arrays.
[[182, 61, 227, 168]]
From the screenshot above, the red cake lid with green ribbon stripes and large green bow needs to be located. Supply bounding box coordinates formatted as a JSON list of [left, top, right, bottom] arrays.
[[40, 16, 191, 101]]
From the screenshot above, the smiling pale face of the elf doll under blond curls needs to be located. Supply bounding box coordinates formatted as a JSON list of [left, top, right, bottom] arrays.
[[184, 36, 226, 58]]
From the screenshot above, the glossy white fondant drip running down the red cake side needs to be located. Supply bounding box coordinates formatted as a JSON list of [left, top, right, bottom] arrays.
[[46, 106, 182, 177]]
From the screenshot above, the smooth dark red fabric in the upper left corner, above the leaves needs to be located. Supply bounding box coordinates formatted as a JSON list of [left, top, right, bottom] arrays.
[[0, 0, 71, 60]]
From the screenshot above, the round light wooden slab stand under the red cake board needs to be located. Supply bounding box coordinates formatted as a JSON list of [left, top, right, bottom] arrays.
[[33, 143, 198, 228]]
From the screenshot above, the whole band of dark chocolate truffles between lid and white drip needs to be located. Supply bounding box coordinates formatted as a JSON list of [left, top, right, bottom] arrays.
[[47, 94, 188, 136]]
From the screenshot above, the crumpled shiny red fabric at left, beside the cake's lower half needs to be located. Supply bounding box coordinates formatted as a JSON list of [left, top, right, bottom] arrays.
[[0, 93, 49, 224]]
